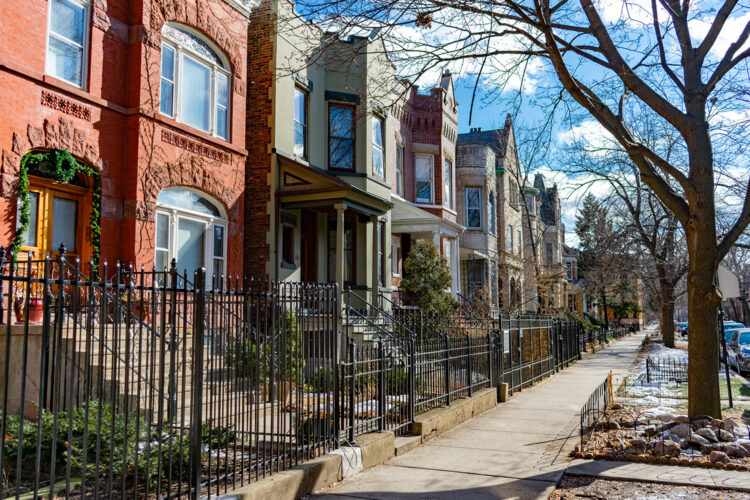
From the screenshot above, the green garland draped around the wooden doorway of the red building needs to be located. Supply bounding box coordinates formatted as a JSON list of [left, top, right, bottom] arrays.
[[11, 149, 102, 271]]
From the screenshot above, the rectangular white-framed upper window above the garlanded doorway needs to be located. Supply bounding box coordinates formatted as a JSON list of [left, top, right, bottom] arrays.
[[46, 0, 90, 88]]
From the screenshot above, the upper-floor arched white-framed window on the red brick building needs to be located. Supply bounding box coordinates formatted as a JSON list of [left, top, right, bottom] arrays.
[[159, 24, 232, 139]]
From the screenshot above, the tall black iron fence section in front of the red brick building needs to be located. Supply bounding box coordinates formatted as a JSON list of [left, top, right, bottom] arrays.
[[0, 257, 339, 498]]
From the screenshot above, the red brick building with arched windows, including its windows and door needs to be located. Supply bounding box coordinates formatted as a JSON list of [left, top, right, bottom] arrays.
[[0, 0, 252, 278]]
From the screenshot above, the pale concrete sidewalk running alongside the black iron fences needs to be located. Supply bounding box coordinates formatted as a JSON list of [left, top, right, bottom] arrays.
[[309, 333, 644, 500]]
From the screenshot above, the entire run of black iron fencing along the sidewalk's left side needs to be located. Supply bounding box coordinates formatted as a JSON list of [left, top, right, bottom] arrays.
[[0, 254, 636, 498]]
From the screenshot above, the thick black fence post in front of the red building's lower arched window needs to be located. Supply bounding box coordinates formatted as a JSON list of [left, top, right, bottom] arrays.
[[190, 267, 206, 500]]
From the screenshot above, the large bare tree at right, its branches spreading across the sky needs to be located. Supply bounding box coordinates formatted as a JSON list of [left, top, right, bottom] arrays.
[[297, 0, 750, 416]]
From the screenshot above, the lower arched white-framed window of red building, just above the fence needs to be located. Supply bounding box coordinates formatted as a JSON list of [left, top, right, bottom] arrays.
[[154, 188, 227, 276]]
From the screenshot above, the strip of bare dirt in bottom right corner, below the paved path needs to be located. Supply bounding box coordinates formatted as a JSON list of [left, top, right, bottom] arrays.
[[550, 476, 750, 500]]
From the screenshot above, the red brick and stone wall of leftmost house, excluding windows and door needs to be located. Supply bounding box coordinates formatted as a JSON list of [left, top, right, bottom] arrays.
[[0, 0, 253, 272]]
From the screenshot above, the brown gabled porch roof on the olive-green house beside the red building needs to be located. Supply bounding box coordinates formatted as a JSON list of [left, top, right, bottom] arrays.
[[274, 150, 393, 216]]
